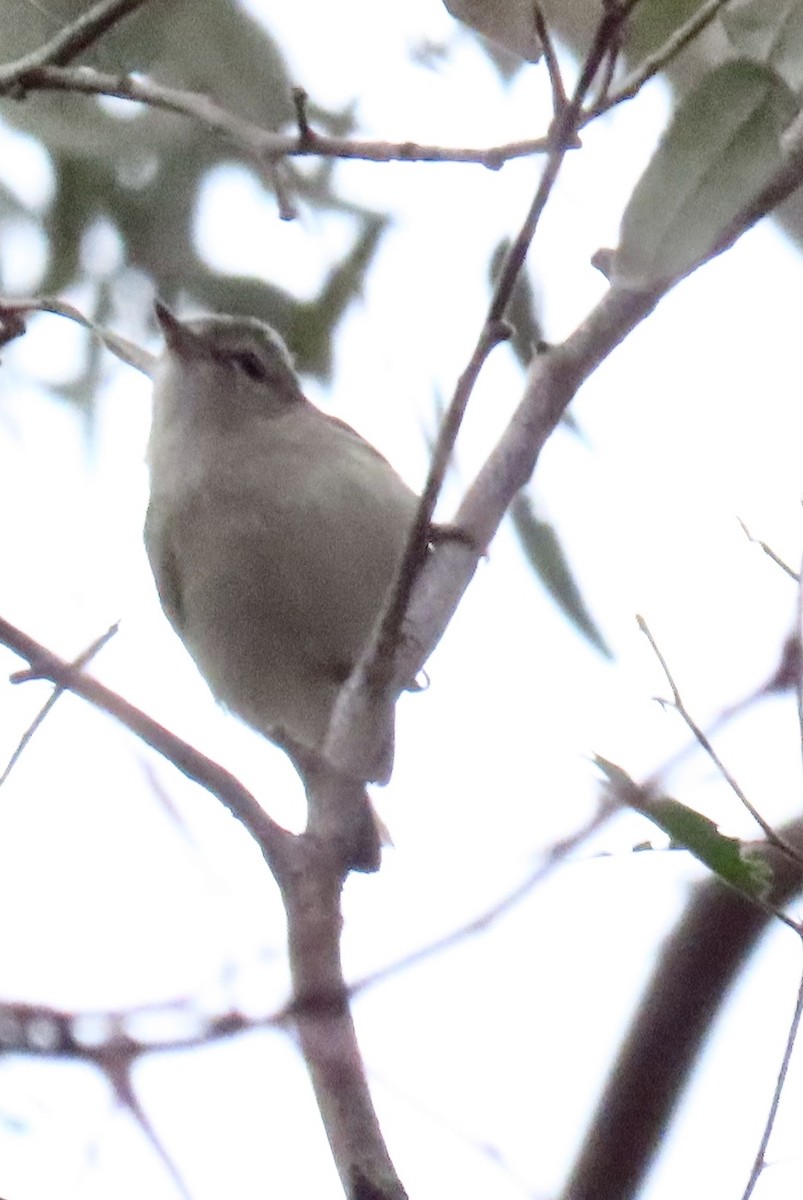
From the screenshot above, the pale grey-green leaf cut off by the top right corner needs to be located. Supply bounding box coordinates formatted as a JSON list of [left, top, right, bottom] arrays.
[[721, 0, 803, 91]]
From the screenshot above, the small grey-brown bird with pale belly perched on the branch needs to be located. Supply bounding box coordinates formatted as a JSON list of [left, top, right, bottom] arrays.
[[145, 302, 418, 870]]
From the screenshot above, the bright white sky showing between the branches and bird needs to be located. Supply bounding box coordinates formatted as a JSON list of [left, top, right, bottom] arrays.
[[0, 0, 803, 1200]]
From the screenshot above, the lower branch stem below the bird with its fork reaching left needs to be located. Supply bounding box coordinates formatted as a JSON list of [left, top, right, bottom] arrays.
[[0, 618, 407, 1200]]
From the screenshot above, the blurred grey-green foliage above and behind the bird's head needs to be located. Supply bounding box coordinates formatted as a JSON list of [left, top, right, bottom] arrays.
[[0, 0, 384, 384]]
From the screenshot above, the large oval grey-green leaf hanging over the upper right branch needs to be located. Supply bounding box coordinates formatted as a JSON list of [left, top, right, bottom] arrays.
[[613, 60, 797, 287]]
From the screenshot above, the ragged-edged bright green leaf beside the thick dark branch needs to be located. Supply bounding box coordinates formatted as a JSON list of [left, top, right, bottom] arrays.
[[594, 755, 773, 900]]
